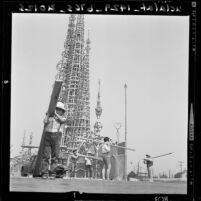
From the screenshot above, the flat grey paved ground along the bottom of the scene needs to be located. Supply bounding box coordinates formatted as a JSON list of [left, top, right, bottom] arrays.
[[10, 177, 187, 194]]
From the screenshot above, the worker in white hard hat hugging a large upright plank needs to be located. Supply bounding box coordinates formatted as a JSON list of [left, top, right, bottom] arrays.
[[41, 102, 66, 178]]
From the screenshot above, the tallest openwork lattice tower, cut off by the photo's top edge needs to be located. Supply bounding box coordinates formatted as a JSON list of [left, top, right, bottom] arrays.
[[56, 15, 90, 152]]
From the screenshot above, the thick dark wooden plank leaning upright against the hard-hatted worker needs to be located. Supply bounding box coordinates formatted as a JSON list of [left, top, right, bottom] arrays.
[[33, 81, 62, 177]]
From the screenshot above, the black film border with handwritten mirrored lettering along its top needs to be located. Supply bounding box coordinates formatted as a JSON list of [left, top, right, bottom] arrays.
[[1, 0, 201, 200]]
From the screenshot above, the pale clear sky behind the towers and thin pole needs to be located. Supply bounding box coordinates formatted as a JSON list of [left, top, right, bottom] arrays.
[[11, 14, 189, 174]]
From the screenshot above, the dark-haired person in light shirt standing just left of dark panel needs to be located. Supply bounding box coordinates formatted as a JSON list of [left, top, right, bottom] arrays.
[[102, 137, 111, 180]]
